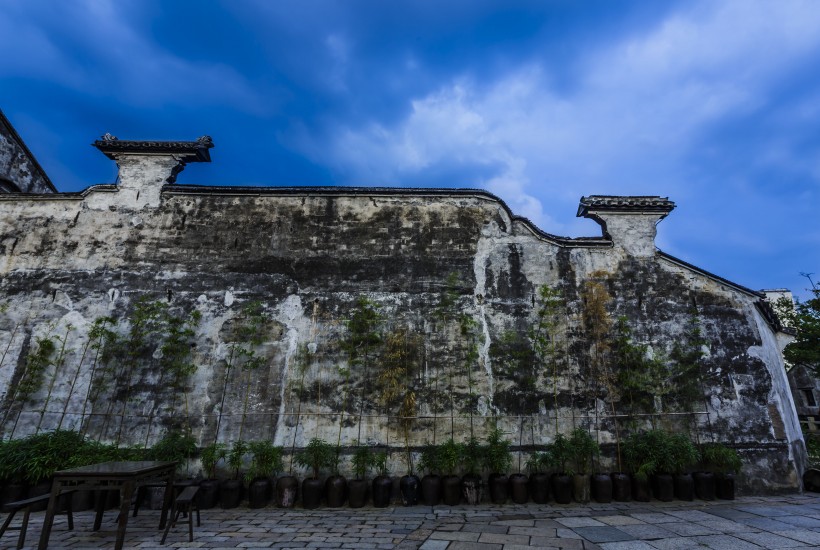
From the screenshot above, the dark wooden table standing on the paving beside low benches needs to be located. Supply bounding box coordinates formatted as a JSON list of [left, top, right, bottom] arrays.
[[38, 461, 177, 550]]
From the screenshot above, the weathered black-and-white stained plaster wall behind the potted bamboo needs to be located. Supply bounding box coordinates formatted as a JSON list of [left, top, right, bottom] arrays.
[[0, 163, 802, 492]]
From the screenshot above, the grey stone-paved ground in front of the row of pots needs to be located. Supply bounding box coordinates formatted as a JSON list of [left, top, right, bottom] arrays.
[[0, 494, 820, 550]]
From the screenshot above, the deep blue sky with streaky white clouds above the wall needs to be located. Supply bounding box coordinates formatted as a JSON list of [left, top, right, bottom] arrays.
[[0, 0, 820, 296]]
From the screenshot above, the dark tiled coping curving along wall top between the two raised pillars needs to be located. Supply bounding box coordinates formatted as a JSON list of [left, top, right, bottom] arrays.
[[167, 184, 612, 247]]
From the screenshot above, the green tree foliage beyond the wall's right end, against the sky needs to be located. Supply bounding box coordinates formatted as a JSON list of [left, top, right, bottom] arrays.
[[777, 275, 820, 376]]
